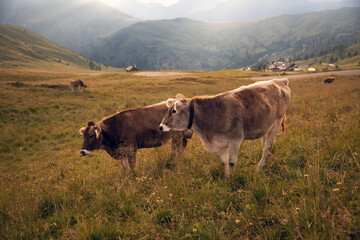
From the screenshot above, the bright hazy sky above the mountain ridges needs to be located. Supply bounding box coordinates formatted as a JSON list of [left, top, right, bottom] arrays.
[[100, 0, 352, 21]]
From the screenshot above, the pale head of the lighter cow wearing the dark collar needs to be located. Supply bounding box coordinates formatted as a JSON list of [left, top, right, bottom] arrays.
[[160, 94, 191, 132]]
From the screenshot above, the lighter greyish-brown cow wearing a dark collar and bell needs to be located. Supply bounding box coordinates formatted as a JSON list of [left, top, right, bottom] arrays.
[[160, 78, 290, 179]]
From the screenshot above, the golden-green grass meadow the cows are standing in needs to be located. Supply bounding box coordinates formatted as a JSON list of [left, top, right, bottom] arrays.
[[0, 69, 360, 239]]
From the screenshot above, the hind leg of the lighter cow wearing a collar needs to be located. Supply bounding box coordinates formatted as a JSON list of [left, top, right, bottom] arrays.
[[256, 119, 283, 171]]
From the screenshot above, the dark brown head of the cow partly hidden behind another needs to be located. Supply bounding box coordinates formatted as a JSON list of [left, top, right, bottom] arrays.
[[79, 122, 103, 156]]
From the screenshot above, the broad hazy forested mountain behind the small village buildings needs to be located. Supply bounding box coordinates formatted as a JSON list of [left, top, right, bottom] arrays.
[[81, 8, 360, 70]]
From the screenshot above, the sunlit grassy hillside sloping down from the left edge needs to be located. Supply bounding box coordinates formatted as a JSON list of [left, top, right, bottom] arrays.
[[0, 24, 104, 70]]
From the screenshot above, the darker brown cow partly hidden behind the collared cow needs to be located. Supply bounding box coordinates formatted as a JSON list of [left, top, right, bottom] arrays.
[[80, 102, 192, 173]]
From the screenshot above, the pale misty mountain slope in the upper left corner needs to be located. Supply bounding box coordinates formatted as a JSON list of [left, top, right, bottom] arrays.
[[0, 0, 140, 51]]
